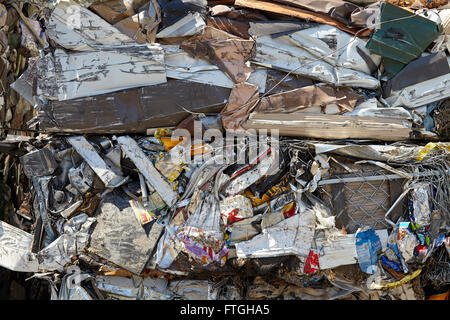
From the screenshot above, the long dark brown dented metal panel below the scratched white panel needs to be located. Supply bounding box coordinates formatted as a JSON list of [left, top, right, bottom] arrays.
[[38, 80, 231, 134]]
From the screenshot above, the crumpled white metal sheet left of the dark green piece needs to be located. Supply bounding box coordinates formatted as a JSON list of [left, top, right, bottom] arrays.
[[251, 25, 380, 89]]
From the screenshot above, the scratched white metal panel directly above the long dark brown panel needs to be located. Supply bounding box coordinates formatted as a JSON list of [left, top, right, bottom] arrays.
[[37, 44, 167, 101]]
